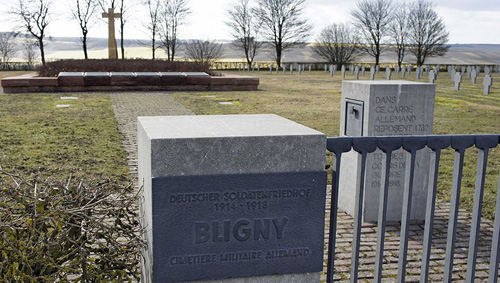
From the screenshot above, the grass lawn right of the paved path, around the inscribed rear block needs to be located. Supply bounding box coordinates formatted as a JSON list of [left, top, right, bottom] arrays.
[[174, 71, 500, 219]]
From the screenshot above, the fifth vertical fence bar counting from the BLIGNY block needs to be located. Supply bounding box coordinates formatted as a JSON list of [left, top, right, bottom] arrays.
[[420, 148, 441, 283]]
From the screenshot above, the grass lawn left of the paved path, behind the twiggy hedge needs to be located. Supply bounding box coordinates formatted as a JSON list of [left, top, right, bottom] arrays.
[[0, 72, 131, 182]]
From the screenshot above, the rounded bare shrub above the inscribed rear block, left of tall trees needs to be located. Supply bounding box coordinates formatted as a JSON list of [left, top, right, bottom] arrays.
[[312, 24, 360, 64]]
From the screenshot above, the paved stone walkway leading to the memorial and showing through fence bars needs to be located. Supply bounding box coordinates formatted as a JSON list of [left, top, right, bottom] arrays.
[[110, 92, 493, 282]]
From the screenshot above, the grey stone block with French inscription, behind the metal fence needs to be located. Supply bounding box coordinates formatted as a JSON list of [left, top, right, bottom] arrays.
[[339, 81, 435, 222]]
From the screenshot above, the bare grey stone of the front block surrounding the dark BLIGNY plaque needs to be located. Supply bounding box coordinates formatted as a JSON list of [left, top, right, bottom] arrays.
[[138, 115, 326, 282]]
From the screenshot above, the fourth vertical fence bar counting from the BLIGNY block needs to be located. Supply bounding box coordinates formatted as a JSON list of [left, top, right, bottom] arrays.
[[397, 150, 417, 282]]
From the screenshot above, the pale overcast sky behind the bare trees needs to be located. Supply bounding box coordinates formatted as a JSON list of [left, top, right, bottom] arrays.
[[0, 0, 500, 44]]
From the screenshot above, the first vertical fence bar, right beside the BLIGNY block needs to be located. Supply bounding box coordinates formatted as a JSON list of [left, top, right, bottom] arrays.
[[326, 152, 342, 283]]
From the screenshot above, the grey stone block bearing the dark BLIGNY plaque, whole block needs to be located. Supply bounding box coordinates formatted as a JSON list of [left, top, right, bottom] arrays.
[[138, 115, 326, 282]]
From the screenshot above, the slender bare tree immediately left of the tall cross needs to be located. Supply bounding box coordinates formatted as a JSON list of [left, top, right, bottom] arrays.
[[70, 0, 97, 59]]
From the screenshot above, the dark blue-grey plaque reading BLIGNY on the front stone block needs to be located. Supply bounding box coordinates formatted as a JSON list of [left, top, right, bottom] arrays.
[[152, 171, 326, 282]]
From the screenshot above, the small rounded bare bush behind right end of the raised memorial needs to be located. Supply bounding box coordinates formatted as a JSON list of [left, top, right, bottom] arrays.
[[186, 39, 224, 65]]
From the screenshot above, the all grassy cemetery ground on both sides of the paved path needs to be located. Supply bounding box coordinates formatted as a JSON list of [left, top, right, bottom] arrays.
[[0, 70, 500, 279]]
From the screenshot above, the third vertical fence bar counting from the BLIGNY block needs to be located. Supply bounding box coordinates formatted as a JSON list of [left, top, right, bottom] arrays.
[[373, 150, 392, 282]]
